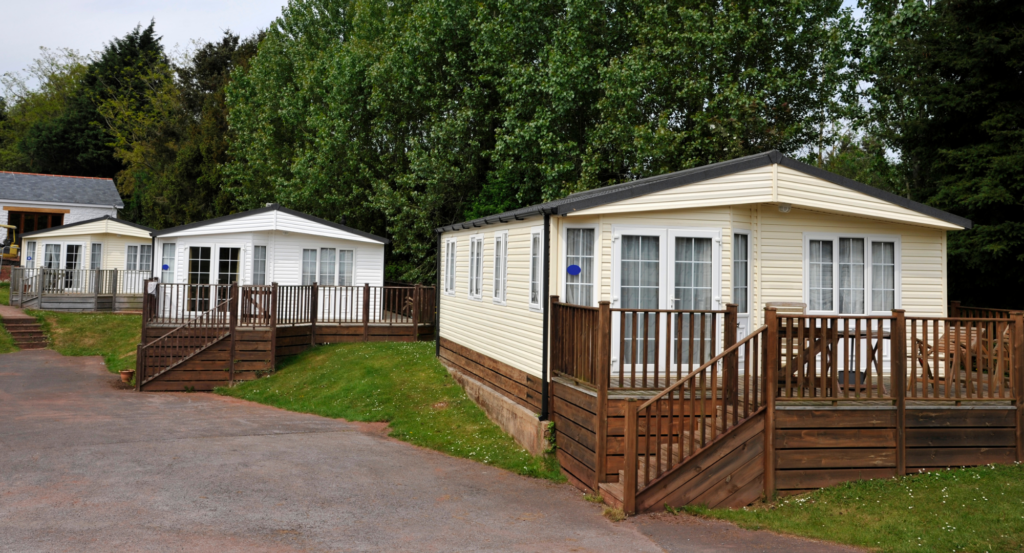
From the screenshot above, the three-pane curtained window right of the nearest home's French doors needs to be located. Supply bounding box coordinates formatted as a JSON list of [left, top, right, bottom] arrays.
[[805, 236, 899, 315]]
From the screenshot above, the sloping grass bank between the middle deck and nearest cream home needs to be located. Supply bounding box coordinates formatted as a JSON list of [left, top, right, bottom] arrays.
[[217, 342, 564, 481]]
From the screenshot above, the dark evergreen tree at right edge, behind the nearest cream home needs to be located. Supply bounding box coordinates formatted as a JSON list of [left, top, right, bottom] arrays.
[[862, 0, 1024, 308]]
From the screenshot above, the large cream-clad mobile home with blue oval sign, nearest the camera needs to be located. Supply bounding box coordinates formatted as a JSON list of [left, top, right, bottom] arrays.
[[437, 152, 971, 460]]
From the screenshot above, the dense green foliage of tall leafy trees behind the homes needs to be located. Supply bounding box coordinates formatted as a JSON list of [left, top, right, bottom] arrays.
[[228, 0, 852, 280]]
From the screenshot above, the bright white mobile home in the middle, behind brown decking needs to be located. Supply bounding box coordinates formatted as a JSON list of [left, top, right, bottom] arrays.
[[154, 204, 388, 286]]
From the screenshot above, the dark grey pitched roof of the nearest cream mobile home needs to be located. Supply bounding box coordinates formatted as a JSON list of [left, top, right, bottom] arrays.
[[436, 150, 971, 232]]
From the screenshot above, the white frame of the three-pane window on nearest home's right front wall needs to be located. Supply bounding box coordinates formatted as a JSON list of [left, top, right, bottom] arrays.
[[803, 232, 903, 316]]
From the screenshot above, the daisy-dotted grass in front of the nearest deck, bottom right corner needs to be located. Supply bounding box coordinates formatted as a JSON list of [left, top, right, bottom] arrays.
[[686, 464, 1024, 553]]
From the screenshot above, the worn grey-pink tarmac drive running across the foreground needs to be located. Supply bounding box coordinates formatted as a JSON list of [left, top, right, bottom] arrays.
[[0, 350, 860, 553]]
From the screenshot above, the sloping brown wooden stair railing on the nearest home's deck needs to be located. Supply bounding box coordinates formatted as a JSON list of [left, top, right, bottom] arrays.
[[623, 327, 767, 512]]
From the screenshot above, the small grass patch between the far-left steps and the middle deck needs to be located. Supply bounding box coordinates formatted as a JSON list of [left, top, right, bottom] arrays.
[[25, 309, 142, 373]]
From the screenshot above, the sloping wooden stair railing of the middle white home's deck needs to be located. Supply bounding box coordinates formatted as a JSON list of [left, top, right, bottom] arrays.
[[135, 285, 238, 390]]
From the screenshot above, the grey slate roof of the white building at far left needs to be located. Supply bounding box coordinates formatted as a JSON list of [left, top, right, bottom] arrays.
[[0, 171, 125, 209]]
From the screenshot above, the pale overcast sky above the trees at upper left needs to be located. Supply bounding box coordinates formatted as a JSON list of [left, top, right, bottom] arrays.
[[0, 0, 287, 79]]
